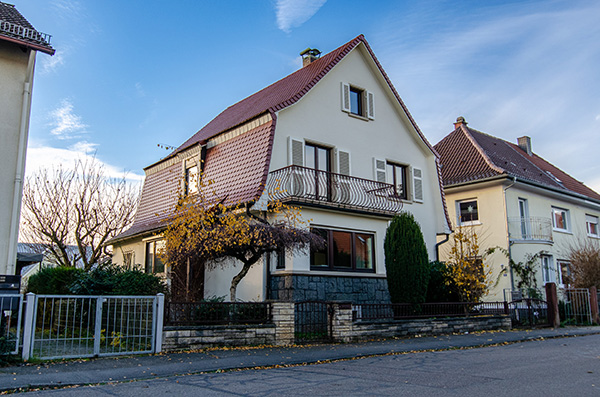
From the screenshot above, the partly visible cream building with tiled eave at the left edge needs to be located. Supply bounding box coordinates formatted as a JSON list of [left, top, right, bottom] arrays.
[[0, 2, 54, 274]]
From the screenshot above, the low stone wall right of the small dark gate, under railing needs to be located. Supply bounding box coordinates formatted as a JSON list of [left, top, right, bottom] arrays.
[[352, 316, 512, 341]]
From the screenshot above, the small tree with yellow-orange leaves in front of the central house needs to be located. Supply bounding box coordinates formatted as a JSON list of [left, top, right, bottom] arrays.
[[161, 179, 324, 302]]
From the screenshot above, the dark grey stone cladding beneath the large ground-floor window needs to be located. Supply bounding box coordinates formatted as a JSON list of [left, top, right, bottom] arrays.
[[271, 274, 390, 304]]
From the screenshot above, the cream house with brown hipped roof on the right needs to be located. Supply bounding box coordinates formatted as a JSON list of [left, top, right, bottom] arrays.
[[435, 117, 600, 300]]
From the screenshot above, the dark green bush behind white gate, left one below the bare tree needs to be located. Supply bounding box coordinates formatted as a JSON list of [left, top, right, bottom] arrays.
[[27, 266, 85, 295]]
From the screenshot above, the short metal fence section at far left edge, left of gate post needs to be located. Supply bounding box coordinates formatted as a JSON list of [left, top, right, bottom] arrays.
[[0, 294, 23, 354]]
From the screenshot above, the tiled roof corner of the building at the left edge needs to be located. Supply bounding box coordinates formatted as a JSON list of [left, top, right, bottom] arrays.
[[0, 1, 54, 55]]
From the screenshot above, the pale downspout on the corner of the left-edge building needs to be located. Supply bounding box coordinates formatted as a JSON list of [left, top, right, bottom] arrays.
[[4, 50, 37, 274]]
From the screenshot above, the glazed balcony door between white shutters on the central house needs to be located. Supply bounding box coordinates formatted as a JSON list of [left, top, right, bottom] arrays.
[[304, 143, 331, 201]]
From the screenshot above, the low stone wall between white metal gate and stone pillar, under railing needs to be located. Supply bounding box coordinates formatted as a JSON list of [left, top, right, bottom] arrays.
[[163, 324, 276, 351]]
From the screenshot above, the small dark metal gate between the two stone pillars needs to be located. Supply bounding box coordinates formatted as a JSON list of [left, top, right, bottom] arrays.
[[294, 301, 334, 343]]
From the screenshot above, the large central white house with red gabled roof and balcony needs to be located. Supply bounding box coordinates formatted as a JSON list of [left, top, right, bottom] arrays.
[[110, 35, 450, 302]]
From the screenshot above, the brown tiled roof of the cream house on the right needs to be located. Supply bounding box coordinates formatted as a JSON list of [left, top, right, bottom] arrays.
[[434, 122, 600, 201]]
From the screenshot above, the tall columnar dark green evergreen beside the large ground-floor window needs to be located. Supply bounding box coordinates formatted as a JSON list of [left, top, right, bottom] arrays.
[[383, 212, 430, 303]]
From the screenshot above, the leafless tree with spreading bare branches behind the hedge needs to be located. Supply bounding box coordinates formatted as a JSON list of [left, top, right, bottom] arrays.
[[21, 159, 139, 270]]
